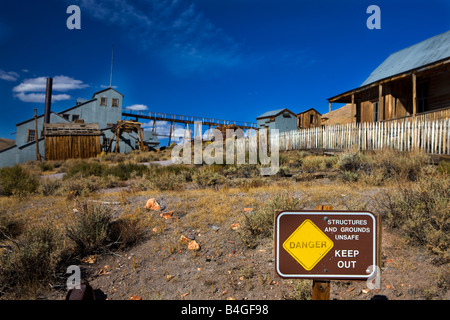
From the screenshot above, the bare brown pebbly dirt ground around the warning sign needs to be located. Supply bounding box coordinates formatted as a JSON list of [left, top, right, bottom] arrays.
[[35, 180, 450, 300]]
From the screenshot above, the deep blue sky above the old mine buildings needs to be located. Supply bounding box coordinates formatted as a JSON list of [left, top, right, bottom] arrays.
[[0, 0, 450, 139]]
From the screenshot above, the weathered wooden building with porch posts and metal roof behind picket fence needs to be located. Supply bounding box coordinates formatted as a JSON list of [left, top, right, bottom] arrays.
[[328, 31, 450, 123]]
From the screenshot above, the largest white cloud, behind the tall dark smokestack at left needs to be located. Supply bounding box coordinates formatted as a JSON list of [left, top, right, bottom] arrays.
[[13, 75, 89, 102]]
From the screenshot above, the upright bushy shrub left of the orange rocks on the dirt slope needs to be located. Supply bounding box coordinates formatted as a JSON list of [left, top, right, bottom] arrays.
[[66, 201, 112, 254]]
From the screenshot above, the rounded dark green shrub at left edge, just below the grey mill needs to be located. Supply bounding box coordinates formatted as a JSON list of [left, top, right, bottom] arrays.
[[0, 165, 39, 197]]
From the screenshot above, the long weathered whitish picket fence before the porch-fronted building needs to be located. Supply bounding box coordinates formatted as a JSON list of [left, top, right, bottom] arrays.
[[272, 118, 450, 155]]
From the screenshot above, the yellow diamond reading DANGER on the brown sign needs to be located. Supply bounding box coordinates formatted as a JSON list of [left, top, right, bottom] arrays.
[[283, 219, 333, 271]]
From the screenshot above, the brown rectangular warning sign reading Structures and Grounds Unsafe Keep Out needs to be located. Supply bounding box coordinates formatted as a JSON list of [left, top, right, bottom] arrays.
[[274, 210, 380, 280]]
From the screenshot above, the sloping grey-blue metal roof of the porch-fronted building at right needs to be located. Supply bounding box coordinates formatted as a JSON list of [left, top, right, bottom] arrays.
[[361, 30, 450, 87]]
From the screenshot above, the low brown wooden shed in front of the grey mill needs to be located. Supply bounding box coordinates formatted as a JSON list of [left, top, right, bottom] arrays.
[[44, 123, 104, 160]]
